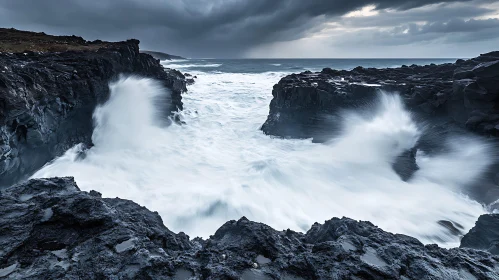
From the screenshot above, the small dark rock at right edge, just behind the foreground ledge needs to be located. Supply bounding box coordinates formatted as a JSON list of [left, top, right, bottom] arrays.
[[460, 214, 499, 255]]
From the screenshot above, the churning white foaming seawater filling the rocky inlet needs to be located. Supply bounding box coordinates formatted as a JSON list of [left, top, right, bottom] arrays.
[[33, 58, 493, 246]]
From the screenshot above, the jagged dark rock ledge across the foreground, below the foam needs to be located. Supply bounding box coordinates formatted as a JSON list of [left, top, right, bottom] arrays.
[[0, 178, 499, 280]]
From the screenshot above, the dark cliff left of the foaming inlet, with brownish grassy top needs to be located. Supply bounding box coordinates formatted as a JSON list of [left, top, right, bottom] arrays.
[[0, 29, 186, 187]]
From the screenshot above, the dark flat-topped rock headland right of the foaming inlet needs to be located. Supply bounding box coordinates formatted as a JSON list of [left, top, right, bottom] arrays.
[[262, 52, 499, 142]]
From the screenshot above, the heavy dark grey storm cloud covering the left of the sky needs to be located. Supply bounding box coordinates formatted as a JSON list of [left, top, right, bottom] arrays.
[[0, 0, 498, 57]]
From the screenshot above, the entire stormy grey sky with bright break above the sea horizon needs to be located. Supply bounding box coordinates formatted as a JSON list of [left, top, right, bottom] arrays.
[[0, 0, 499, 58]]
